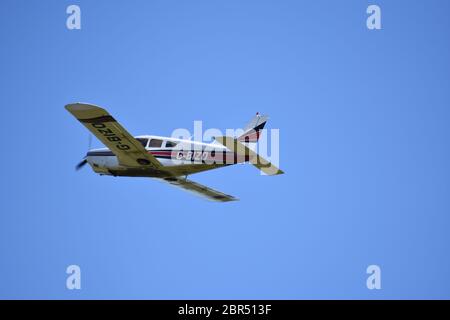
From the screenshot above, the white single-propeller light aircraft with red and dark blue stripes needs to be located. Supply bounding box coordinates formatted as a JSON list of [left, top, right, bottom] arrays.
[[65, 103, 283, 202]]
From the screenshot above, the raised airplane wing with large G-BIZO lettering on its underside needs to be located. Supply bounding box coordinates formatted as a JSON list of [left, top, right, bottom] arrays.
[[66, 103, 161, 169]]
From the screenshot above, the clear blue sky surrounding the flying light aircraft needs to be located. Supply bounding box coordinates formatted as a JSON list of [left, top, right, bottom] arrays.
[[0, 0, 450, 299]]
